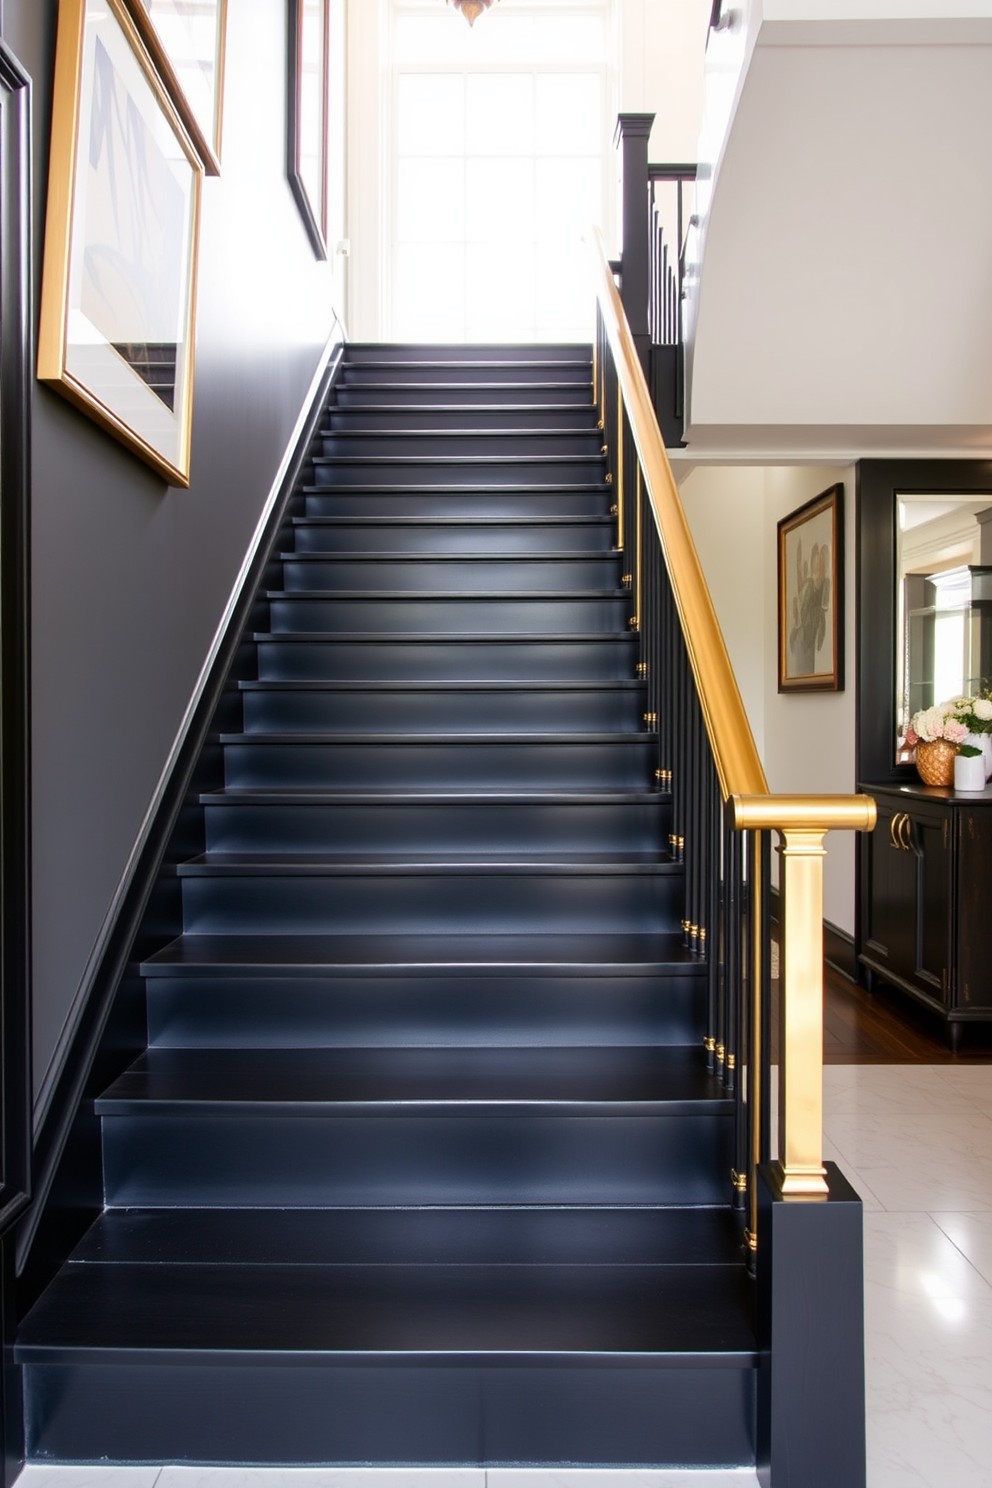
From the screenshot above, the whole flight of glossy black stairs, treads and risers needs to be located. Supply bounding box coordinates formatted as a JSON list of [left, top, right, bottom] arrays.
[[16, 347, 756, 1466]]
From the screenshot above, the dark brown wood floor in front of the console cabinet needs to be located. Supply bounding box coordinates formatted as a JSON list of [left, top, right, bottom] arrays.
[[824, 966, 992, 1064]]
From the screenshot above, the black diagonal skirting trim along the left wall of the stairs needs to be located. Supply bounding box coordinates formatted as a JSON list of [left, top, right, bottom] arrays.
[[16, 336, 344, 1275]]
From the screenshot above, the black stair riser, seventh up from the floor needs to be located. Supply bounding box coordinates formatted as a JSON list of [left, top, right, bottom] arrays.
[[241, 683, 644, 734]]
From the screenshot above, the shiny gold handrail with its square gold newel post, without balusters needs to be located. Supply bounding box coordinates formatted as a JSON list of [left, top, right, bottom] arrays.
[[586, 228, 876, 1208]]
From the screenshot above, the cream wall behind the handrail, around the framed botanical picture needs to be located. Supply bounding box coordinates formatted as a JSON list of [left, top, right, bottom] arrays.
[[680, 466, 855, 934]]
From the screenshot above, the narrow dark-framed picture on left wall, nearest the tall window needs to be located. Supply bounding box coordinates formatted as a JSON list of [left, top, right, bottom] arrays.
[[287, 0, 332, 259]]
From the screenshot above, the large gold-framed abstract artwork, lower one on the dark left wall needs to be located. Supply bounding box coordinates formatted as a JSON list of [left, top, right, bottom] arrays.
[[37, 0, 204, 485]]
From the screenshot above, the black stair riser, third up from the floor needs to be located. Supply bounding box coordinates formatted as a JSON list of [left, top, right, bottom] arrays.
[[149, 975, 706, 1049]]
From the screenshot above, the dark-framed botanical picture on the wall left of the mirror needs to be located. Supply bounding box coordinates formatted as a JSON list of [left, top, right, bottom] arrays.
[[778, 485, 843, 692]]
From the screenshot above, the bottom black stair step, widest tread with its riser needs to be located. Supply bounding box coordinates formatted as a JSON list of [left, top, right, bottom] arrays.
[[16, 1210, 756, 1466]]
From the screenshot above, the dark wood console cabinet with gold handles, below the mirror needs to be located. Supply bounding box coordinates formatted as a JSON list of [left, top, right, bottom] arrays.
[[858, 784, 992, 1048]]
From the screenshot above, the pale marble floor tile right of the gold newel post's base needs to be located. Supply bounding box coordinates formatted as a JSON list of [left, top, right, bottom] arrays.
[[827, 1110, 992, 1213]]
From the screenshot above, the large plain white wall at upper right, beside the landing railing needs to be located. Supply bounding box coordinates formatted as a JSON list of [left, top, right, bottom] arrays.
[[687, 0, 992, 458]]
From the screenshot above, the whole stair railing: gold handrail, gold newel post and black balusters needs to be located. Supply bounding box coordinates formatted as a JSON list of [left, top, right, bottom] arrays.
[[589, 229, 876, 1248]]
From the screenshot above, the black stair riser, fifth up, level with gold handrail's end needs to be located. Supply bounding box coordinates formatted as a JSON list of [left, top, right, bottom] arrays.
[[205, 798, 671, 859]]
